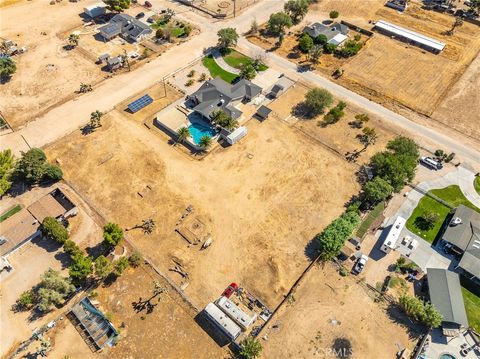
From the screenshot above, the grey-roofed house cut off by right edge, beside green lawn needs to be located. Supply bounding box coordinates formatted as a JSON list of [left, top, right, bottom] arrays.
[[442, 205, 480, 280]]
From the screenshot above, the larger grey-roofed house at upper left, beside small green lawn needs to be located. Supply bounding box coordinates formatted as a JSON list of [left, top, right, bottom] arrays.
[[98, 14, 152, 42]]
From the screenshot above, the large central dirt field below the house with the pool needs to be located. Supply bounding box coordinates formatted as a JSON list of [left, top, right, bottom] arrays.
[[47, 104, 359, 307]]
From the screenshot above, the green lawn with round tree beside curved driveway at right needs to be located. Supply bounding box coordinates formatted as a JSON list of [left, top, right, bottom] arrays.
[[407, 185, 480, 243]]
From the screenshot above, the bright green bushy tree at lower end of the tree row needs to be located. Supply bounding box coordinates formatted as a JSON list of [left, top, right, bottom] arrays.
[[315, 211, 360, 261]]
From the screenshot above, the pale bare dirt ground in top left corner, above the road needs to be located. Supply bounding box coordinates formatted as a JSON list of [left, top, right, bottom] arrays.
[[0, 0, 104, 129]]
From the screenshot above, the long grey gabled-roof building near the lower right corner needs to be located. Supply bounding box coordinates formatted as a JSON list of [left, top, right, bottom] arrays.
[[427, 268, 468, 336]]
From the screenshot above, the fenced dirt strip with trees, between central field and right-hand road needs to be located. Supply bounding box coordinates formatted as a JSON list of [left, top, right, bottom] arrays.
[[269, 83, 399, 163]]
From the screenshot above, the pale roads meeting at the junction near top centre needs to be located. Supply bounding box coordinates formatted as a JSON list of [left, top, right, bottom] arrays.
[[0, 0, 480, 168]]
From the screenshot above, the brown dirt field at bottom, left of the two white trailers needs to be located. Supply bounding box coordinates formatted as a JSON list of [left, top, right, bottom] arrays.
[[37, 266, 227, 358]]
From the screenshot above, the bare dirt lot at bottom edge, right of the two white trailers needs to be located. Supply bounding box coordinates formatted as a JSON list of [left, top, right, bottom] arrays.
[[262, 264, 420, 358]]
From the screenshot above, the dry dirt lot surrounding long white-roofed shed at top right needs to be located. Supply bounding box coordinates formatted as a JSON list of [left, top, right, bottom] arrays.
[[250, 0, 480, 137]]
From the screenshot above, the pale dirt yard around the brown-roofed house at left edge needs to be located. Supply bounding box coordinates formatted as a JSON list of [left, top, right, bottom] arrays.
[[0, 185, 102, 354]]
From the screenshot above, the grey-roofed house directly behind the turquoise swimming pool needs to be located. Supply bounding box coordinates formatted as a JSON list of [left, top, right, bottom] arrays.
[[188, 77, 262, 121]]
